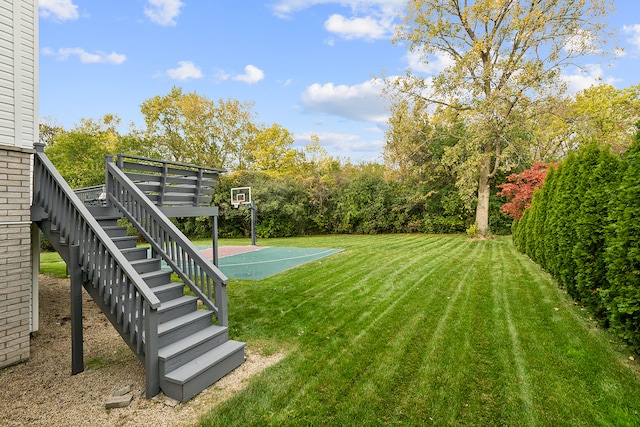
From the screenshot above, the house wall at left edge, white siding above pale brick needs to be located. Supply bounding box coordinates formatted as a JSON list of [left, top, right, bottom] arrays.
[[0, 0, 38, 367]]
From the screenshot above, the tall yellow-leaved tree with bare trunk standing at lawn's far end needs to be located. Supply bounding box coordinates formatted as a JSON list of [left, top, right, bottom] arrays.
[[395, 0, 611, 235]]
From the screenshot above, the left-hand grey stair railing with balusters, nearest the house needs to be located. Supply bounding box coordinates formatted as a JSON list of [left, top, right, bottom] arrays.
[[33, 143, 161, 397]]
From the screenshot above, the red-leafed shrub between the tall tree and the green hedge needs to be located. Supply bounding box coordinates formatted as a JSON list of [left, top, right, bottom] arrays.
[[498, 162, 557, 221]]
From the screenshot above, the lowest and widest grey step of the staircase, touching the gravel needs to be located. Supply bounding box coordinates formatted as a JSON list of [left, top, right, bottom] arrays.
[[160, 341, 245, 402]]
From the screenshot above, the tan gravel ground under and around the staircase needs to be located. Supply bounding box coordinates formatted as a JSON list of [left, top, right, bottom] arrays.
[[0, 275, 283, 427]]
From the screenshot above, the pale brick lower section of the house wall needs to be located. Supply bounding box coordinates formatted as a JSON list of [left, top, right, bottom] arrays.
[[0, 146, 32, 367]]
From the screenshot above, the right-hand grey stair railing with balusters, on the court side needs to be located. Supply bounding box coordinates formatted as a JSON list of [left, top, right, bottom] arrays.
[[105, 155, 229, 326]]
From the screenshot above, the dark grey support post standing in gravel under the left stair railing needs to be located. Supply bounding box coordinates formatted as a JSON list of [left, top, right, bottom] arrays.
[[69, 245, 84, 375]]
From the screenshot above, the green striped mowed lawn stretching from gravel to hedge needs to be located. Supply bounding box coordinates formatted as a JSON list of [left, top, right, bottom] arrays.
[[194, 235, 640, 426]]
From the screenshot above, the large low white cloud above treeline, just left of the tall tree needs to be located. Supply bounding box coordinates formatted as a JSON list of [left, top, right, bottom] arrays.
[[302, 80, 389, 124]]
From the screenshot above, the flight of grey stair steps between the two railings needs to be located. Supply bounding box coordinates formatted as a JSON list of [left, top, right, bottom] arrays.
[[94, 207, 245, 402]]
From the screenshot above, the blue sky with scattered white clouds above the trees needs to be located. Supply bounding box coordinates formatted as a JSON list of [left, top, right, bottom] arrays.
[[39, 0, 640, 162]]
